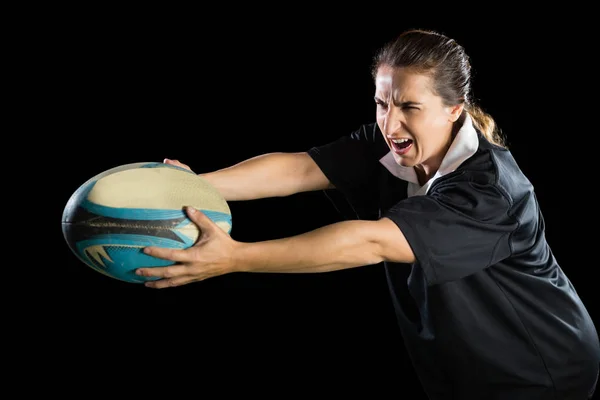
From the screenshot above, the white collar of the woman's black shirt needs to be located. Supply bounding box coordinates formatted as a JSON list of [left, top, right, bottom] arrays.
[[379, 113, 479, 196]]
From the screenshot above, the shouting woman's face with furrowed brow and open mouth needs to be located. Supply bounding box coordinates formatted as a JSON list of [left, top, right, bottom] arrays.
[[375, 65, 462, 175]]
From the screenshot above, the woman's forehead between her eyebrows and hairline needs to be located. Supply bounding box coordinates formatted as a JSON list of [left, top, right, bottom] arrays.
[[375, 65, 433, 97]]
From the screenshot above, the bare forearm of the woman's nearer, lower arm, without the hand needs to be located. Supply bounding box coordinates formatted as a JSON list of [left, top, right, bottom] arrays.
[[234, 221, 383, 273]]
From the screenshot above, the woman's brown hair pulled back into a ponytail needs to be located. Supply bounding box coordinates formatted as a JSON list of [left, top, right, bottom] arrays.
[[371, 29, 506, 147]]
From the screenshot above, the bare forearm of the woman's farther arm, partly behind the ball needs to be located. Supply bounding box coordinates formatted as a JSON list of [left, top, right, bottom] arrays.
[[199, 153, 328, 201]]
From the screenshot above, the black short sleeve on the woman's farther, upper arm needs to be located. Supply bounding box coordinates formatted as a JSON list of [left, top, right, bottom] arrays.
[[308, 125, 378, 218]]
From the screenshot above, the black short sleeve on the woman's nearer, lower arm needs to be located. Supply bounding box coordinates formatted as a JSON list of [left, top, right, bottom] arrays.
[[382, 179, 518, 285]]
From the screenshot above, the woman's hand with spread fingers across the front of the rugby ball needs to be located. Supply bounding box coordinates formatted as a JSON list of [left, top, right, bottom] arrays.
[[136, 207, 240, 289]]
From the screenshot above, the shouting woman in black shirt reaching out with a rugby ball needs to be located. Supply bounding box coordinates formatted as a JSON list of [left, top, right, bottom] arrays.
[[138, 30, 600, 400]]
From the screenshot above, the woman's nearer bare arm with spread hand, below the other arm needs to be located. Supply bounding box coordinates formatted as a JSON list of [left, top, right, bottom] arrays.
[[138, 208, 414, 288]]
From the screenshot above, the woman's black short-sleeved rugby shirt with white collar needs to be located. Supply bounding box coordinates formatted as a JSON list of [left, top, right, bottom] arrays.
[[308, 115, 600, 399]]
